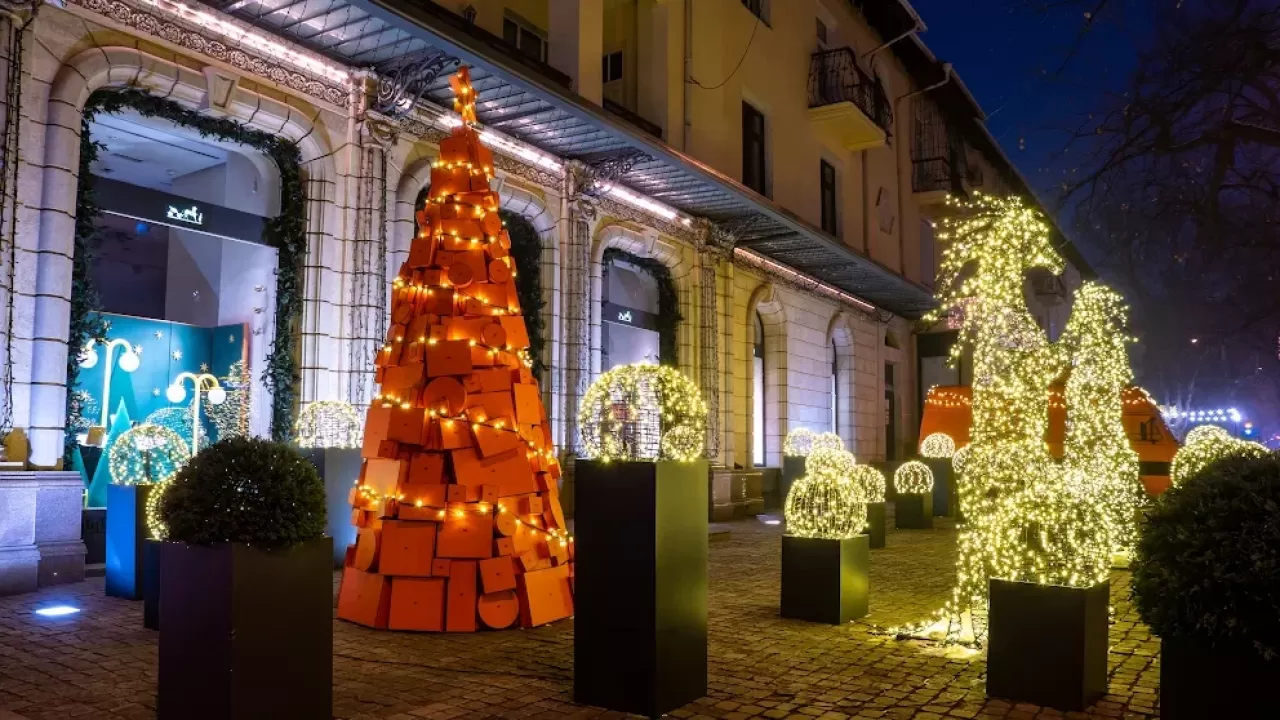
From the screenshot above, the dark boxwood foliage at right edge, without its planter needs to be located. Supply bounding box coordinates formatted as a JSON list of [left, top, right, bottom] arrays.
[[1133, 455, 1280, 660]]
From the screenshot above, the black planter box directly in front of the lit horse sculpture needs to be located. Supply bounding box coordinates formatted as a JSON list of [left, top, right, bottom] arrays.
[[987, 579, 1105, 717]]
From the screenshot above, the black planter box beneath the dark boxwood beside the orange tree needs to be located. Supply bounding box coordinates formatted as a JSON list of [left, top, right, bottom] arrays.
[[157, 538, 333, 720]]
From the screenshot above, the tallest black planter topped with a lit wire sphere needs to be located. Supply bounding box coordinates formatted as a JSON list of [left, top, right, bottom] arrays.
[[573, 364, 708, 717]]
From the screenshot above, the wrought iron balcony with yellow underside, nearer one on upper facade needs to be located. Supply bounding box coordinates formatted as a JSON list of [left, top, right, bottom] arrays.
[[809, 47, 893, 150]]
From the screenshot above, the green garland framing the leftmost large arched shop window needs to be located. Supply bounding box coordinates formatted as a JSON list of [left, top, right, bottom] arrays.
[[67, 87, 307, 448]]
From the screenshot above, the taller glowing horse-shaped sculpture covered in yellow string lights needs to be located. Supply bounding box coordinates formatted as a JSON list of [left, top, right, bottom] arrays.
[[925, 193, 1110, 641]]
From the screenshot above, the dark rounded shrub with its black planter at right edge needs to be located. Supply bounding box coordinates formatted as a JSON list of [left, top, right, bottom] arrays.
[[1133, 454, 1280, 720]]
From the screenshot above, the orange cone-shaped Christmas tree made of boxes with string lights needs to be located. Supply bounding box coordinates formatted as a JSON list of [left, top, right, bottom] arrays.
[[338, 68, 573, 632]]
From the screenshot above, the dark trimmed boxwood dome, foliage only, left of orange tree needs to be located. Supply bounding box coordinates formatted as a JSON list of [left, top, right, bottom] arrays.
[[159, 437, 325, 550]]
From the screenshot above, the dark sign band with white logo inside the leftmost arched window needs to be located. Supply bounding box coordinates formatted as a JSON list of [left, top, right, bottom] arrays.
[[93, 177, 266, 243]]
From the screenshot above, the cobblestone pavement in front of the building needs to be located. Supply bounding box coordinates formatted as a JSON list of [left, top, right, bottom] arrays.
[[0, 520, 1160, 720]]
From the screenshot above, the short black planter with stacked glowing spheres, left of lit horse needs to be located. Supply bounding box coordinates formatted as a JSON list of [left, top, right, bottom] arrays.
[[781, 448, 870, 625]]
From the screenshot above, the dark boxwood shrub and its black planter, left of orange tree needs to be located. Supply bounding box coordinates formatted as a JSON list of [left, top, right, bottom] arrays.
[[157, 437, 333, 720]]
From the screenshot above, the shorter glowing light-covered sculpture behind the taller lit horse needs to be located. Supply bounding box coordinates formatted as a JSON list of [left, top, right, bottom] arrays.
[[1060, 282, 1146, 553]]
